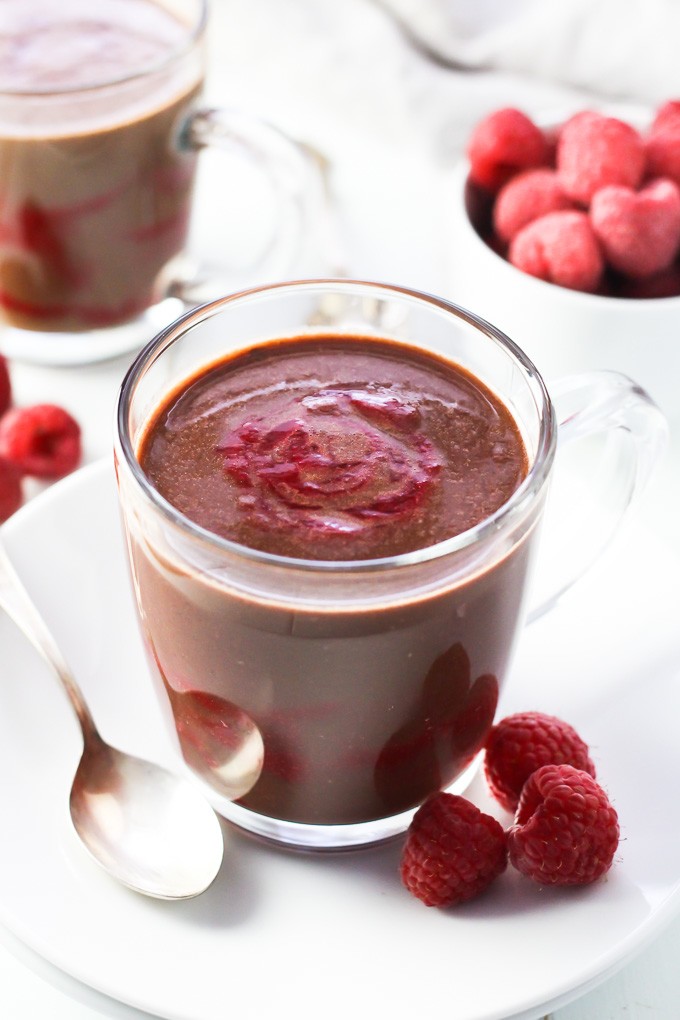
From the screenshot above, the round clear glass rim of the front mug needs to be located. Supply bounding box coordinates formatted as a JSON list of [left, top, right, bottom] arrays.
[[115, 277, 557, 574]]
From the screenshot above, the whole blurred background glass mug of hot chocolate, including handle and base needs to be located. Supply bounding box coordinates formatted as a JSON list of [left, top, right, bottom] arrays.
[[0, 0, 323, 364]]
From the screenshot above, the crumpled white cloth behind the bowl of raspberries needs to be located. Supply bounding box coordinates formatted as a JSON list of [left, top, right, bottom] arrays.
[[375, 0, 680, 103]]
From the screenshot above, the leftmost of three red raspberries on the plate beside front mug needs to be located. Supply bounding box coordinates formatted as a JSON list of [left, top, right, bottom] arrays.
[[401, 794, 508, 907]]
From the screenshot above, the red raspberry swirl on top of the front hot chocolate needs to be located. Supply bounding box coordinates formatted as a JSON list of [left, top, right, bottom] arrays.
[[217, 387, 442, 537]]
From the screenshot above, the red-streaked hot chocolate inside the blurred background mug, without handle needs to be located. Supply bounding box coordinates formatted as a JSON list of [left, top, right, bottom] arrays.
[[0, 0, 200, 332]]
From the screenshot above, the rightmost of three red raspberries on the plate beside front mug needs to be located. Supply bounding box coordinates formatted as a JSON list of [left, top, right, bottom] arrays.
[[508, 765, 619, 885]]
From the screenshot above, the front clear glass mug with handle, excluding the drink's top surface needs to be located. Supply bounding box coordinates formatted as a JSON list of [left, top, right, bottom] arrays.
[[115, 281, 665, 849]]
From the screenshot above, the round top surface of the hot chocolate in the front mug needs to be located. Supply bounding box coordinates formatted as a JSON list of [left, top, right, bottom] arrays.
[[140, 336, 526, 560]]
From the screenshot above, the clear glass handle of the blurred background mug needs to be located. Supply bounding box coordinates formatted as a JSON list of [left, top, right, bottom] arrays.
[[169, 108, 332, 297]]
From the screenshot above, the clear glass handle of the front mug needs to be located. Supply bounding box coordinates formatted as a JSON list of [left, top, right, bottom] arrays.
[[527, 371, 668, 622]]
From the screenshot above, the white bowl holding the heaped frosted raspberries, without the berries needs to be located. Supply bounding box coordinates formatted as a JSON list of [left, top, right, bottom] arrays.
[[448, 148, 680, 418]]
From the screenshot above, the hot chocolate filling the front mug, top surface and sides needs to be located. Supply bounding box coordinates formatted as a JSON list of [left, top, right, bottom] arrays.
[[130, 336, 531, 824]]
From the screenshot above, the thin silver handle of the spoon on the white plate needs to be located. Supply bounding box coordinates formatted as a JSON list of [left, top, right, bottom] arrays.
[[0, 542, 99, 740]]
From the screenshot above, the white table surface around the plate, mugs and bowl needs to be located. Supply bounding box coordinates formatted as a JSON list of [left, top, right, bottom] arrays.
[[0, 0, 680, 1020]]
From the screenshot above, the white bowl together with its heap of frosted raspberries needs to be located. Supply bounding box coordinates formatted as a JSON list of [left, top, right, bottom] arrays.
[[450, 100, 680, 416]]
